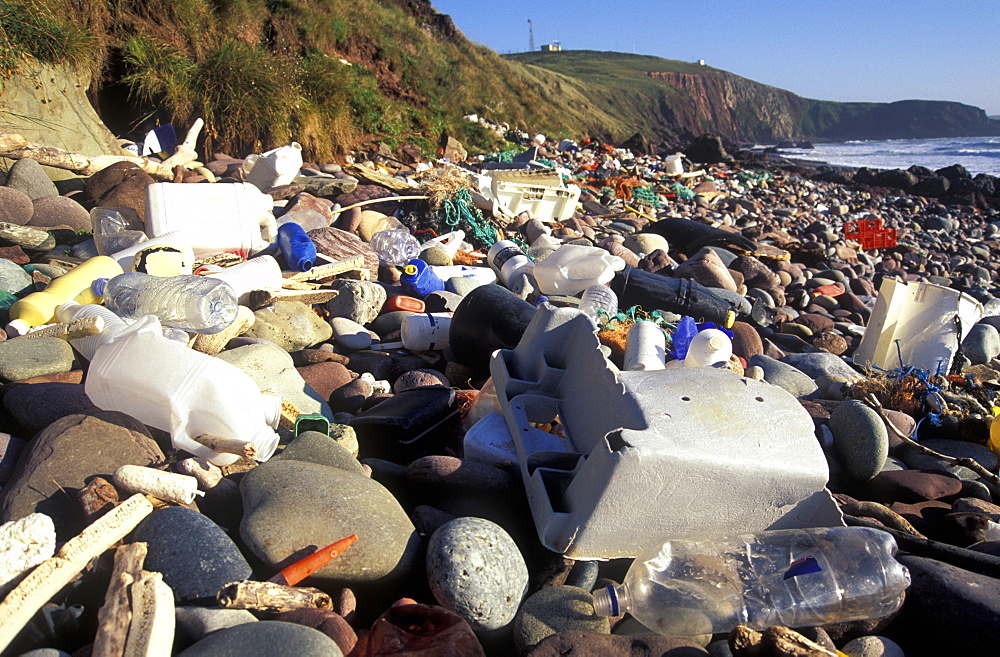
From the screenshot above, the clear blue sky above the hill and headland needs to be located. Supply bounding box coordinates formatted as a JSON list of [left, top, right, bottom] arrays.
[[432, 0, 1000, 115]]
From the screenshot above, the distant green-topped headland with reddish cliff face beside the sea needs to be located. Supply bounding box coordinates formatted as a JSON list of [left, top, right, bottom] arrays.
[[507, 50, 1000, 142]]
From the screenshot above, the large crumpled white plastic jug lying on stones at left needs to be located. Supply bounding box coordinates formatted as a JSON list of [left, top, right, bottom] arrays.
[[84, 315, 281, 466]]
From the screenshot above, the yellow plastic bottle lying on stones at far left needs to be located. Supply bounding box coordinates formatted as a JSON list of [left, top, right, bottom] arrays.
[[8, 256, 122, 333]]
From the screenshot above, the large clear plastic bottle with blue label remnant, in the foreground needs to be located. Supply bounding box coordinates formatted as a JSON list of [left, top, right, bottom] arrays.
[[594, 527, 910, 637]]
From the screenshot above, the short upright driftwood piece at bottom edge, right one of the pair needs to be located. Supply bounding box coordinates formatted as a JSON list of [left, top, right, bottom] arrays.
[[124, 570, 174, 657]]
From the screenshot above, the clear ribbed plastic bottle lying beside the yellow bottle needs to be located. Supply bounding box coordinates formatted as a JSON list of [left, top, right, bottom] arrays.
[[93, 271, 237, 333]]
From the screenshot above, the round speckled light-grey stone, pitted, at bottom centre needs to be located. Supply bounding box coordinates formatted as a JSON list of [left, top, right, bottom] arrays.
[[427, 517, 528, 631]]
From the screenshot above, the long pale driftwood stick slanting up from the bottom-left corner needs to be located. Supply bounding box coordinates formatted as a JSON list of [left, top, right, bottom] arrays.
[[0, 495, 153, 652]]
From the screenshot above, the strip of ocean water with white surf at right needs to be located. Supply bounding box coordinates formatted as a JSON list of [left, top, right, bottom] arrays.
[[753, 137, 1000, 176]]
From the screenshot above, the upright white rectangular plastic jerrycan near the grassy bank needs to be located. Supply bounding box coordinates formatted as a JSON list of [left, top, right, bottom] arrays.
[[146, 183, 277, 258]]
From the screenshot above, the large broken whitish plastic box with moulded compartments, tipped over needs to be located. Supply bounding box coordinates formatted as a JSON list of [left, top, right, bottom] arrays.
[[484, 305, 843, 559]]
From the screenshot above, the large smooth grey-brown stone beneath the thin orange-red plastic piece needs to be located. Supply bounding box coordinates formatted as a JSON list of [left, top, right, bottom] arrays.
[[240, 460, 420, 583]]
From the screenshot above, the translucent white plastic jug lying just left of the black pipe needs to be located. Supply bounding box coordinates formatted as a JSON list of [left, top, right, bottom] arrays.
[[532, 244, 625, 295]]
